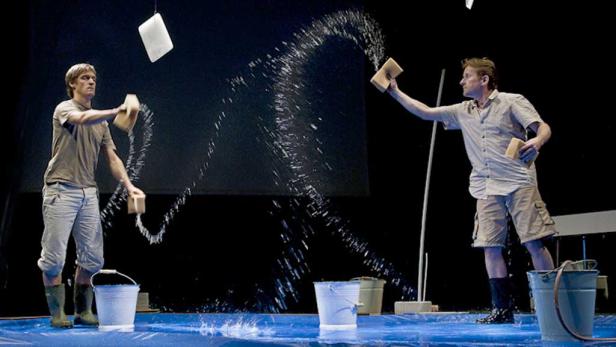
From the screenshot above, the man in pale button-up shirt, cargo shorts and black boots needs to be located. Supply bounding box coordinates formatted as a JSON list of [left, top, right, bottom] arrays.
[[388, 58, 555, 324]]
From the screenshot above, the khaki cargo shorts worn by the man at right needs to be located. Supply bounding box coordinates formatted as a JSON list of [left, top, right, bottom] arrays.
[[473, 187, 556, 247]]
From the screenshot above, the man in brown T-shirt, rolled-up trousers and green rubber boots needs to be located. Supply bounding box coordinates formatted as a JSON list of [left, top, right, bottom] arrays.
[[37, 64, 143, 328]]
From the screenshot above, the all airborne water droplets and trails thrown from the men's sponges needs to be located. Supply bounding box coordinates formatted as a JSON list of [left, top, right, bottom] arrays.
[[102, 10, 413, 312]]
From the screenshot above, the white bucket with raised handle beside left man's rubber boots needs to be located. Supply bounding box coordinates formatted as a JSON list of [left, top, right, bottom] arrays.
[[90, 270, 139, 332]]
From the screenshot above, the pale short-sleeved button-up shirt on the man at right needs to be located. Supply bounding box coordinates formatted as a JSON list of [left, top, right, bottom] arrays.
[[438, 90, 543, 199]]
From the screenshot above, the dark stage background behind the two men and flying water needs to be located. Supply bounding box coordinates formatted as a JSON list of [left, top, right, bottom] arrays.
[[0, 0, 616, 316]]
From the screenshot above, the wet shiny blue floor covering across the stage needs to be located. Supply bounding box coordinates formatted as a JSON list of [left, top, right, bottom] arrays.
[[0, 313, 616, 346]]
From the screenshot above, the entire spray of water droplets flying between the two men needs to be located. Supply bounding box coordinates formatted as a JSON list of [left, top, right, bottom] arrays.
[[103, 10, 414, 312]]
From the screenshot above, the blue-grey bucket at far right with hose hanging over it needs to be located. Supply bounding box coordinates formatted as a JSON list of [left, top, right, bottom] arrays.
[[526, 270, 598, 341]]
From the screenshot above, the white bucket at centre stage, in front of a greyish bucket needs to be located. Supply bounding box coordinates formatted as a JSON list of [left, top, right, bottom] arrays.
[[314, 281, 361, 329]]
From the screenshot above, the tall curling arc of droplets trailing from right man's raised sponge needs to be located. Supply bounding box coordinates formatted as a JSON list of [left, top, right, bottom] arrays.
[[273, 7, 414, 309]]
